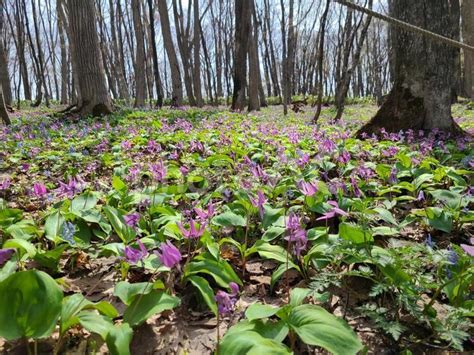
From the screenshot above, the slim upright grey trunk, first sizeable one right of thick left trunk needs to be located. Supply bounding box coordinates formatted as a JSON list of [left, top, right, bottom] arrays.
[[132, 0, 146, 107]]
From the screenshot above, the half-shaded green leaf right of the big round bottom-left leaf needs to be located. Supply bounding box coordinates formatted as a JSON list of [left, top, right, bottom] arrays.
[[123, 290, 181, 327]]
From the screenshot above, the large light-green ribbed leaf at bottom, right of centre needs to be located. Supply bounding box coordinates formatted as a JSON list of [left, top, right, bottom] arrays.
[[288, 304, 363, 355]]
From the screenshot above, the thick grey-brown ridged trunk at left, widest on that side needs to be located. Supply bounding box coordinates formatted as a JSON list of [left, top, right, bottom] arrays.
[[67, 0, 112, 116]]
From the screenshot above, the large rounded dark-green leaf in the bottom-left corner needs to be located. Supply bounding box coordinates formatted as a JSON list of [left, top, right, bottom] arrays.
[[0, 270, 63, 340]]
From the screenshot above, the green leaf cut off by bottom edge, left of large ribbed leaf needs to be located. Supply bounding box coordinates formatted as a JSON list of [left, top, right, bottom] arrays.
[[219, 331, 292, 355]]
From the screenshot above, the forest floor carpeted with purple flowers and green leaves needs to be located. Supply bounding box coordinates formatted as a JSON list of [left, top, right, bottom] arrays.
[[0, 103, 474, 355]]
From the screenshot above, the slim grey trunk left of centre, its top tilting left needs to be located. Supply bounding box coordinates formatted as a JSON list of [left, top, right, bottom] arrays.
[[158, 1, 183, 106]]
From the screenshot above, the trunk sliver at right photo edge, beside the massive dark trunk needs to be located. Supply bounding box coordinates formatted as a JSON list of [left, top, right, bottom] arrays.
[[462, 0, 474, 100]]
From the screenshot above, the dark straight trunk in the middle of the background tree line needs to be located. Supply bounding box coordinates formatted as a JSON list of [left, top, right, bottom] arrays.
[[232, 0, 250, 111]]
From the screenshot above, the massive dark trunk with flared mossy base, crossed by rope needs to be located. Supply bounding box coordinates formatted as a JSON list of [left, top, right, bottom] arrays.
[[358, 0, 459, 136]]
